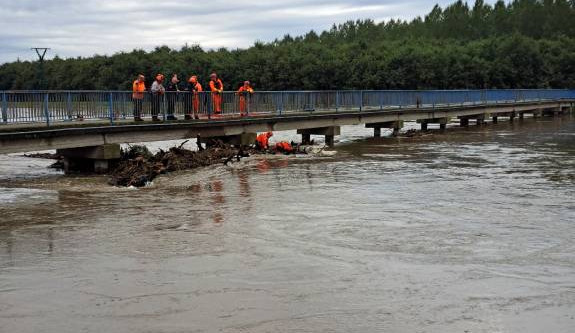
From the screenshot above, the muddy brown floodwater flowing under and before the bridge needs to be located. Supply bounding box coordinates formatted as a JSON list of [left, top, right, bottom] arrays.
[[0, 117, 575, 333]]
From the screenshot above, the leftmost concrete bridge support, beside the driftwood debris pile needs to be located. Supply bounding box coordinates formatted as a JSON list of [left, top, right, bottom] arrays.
[[56, 144, 121, 173]]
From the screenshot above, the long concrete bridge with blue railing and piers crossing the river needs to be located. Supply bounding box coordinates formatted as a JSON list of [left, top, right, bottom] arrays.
[[0, 90, 575, 171]]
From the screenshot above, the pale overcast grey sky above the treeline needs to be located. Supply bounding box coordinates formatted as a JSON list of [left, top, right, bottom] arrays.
[[0, 0, 500, 63]]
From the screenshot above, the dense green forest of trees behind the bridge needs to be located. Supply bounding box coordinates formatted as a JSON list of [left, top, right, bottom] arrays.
[[0, 0, 575, 90]]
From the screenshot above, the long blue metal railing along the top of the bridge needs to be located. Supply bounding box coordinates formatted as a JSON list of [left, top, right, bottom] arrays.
[[0, 89, 575, 126]]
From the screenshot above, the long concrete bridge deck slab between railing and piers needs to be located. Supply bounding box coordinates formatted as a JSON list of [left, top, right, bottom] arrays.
[[0, 100, 574, 153]]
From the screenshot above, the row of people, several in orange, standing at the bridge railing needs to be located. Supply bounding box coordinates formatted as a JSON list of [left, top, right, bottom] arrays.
[[132, 73, 254, 121]]
